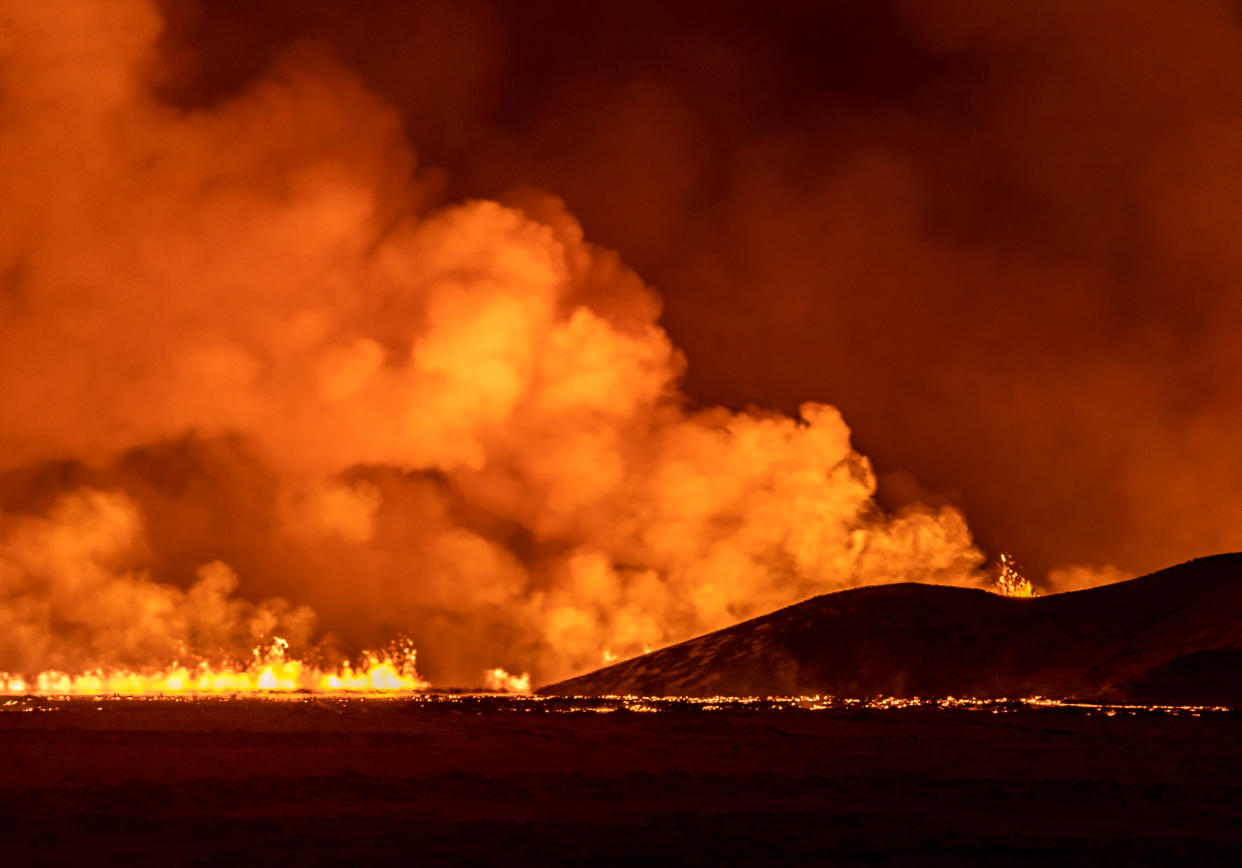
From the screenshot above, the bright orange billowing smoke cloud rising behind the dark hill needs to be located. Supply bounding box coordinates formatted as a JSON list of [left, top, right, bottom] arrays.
[[0, 0, 981, 683]]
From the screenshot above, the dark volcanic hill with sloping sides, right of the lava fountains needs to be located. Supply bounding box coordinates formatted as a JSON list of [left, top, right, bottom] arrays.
[[538, 554, 1242, 705]]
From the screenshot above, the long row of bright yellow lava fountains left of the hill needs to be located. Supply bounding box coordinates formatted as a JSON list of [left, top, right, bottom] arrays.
[[0, 637, 429, 697]]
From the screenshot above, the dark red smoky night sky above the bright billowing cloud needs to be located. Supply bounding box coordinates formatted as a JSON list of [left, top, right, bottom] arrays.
[[183, 0, 1242, 590]]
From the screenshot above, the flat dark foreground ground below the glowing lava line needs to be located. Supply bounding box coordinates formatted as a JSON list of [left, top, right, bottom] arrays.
[[0, 698, 1242, 866]]
